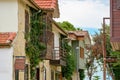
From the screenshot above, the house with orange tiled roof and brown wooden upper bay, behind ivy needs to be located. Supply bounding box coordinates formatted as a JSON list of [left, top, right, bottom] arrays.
[[34, 0, 61, 80]]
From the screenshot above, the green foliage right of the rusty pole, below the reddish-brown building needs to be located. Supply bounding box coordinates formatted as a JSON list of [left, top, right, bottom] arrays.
[[93, 25, 120, 80]]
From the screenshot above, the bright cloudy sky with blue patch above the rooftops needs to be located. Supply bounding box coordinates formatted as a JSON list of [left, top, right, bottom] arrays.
[[55, 0, 110, 35]]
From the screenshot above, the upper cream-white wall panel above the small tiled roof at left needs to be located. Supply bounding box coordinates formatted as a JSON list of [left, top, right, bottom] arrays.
[[0, 0, 18, 32]]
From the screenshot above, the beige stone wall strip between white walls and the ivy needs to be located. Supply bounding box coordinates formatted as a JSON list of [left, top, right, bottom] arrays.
[[13, 0, 30, 80]]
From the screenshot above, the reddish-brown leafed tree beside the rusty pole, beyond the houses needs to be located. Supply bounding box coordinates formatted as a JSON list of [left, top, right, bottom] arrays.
[[86, 25, 111, 80]]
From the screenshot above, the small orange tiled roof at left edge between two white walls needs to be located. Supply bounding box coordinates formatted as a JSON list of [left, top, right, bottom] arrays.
[[0, 32, 16, 45]]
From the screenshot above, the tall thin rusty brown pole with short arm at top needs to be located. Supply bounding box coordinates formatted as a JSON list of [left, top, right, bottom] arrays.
[[103, 17, 110, 80]]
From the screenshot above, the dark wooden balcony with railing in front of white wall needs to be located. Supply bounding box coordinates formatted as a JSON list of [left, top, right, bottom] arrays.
[[50, 47, 66, 66]]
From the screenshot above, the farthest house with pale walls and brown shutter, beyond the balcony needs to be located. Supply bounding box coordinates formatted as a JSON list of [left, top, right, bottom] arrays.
[[68, 31, 91, 80]]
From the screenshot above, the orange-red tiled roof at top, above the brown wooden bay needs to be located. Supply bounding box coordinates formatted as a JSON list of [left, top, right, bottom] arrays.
[[34, 0, 57, 10]]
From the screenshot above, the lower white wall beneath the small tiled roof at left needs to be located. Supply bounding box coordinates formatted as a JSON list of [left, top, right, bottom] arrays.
[[0, 48, 13, 80]]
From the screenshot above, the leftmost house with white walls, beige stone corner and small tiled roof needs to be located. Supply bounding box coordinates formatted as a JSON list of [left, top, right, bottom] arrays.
[[0, 0, 39, 80]]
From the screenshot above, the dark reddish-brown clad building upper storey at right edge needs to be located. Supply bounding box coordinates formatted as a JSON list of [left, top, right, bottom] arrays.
[[110, 0, 120, 51]]
